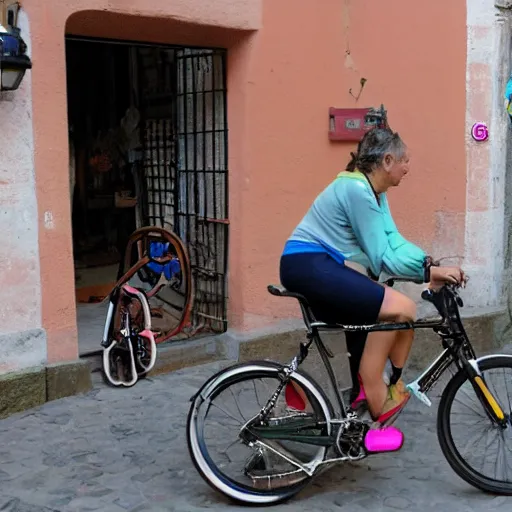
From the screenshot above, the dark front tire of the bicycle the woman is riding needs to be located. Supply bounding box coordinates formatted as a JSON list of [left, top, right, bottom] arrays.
[[437, 355, 512, 496]]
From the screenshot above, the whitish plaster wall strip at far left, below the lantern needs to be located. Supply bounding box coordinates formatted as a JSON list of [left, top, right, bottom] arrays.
[[0, 11, 46, 372]]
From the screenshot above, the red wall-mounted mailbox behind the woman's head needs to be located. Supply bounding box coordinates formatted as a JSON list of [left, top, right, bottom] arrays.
[[329, 106, 387, 142]]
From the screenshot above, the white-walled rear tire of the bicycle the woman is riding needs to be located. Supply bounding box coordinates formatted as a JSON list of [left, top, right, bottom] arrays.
[[187, 361, 334, 506]]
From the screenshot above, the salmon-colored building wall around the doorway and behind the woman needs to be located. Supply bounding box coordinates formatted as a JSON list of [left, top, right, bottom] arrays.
[[17, 0, 466, 368]]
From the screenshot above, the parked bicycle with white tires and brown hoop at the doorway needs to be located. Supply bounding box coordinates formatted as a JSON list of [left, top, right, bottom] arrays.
[[101, 226, 192, 387]]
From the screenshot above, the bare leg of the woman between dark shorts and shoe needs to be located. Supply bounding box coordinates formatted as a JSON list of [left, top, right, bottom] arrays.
[[360, 288, 416, 418]]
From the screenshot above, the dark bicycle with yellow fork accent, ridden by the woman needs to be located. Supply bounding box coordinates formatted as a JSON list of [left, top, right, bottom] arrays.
[[187, 277, 512, 505]]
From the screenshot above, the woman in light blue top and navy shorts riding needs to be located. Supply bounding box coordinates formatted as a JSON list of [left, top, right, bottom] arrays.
[[280, 128, 464, 448]]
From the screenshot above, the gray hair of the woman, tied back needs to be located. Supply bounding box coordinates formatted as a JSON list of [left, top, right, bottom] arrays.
[[346, 128, 406, 173]]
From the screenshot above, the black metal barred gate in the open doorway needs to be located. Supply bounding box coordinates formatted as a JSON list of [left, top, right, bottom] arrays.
[[137, 48, 229, 334]]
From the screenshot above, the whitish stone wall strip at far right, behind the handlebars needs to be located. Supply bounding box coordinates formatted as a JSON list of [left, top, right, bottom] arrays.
[[464, 0, 512, 313]]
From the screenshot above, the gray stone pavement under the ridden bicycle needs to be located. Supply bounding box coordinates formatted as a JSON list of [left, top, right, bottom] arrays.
[[0, 363, 512, 512]]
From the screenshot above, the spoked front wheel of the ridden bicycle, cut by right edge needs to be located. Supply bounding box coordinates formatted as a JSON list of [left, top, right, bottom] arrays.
[[437, 355, 512, 495]]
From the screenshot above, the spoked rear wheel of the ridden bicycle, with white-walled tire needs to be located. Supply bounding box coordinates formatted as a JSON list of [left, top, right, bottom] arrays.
[[187, 361, 332, 505]]
